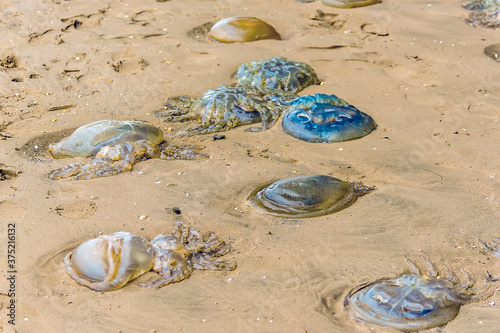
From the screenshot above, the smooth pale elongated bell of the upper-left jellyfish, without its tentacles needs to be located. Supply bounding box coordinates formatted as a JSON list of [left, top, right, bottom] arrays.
[[49, 120, 163, 158]]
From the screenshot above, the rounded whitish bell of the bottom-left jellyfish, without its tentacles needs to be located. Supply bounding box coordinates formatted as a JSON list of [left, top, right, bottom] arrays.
[[64, 232, 153, 291]]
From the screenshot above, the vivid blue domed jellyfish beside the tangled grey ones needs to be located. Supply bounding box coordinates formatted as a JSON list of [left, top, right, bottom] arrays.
[[283, 94, 377, 143]]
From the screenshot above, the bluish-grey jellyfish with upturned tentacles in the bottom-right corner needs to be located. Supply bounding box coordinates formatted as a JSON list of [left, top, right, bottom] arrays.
[[344, 259, 491, 332]]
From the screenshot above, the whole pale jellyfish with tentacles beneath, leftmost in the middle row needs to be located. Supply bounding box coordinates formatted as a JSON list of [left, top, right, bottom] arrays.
[[49, 120, 201, 180]]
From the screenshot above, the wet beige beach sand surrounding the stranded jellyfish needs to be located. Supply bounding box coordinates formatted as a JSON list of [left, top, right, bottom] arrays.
[[0, 0, 500, 333]]
